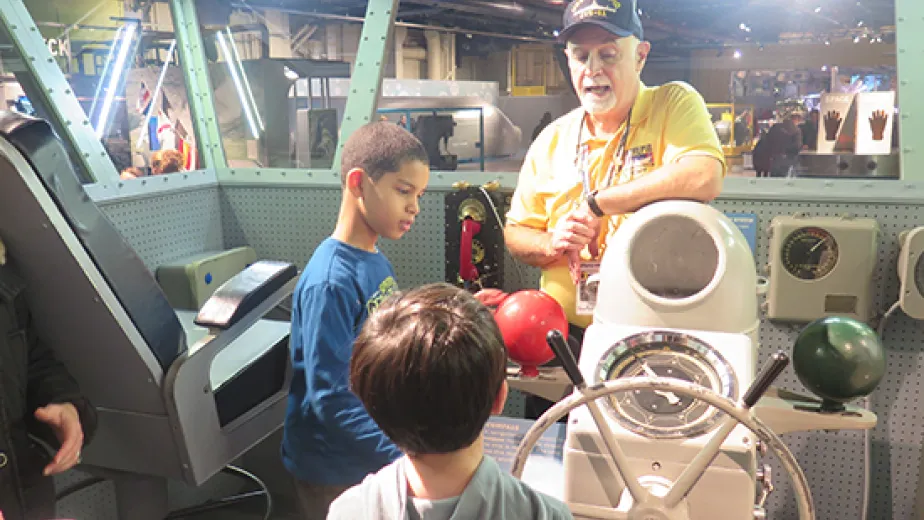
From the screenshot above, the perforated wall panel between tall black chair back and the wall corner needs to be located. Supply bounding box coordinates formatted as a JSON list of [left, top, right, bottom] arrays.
[[100, 187, 224, 271]]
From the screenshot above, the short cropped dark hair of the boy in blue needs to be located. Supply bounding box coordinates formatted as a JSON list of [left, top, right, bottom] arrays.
[[340, 121, 430, 183]]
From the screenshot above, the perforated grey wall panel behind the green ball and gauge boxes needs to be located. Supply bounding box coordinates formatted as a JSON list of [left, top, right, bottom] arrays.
[[715, 199, 924, 520]]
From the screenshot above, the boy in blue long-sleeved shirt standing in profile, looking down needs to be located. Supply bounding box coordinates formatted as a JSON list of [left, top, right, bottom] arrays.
[[281, 122, 430, 519]]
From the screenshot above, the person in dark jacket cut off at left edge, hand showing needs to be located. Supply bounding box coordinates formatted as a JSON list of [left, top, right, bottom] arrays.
[[0, 241, 96, 520]]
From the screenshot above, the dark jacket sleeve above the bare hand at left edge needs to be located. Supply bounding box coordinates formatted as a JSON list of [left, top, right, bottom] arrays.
[[17, 294, 96, 446]]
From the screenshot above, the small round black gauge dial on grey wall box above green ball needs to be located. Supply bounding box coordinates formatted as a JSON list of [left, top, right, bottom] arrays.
[[780, 227, 839, 280]]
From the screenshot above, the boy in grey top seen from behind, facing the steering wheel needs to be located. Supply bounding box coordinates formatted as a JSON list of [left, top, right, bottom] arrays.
[[328, 283, 572, 520]]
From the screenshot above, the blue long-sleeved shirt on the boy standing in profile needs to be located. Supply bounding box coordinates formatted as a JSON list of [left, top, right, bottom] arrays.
[[282, 238, 401, 485]]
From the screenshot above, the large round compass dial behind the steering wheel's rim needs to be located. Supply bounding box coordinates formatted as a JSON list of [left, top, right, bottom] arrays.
[[595, 331, 738, 439]]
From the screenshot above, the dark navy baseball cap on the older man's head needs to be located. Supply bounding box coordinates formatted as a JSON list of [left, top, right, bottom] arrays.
[[558, 0, 644, 42]]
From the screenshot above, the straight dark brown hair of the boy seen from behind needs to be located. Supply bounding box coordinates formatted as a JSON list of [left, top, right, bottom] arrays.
[[350, 283, 507, 455]]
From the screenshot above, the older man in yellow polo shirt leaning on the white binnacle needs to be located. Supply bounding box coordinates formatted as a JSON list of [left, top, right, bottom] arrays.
[[504, 0, 726, 415]]
